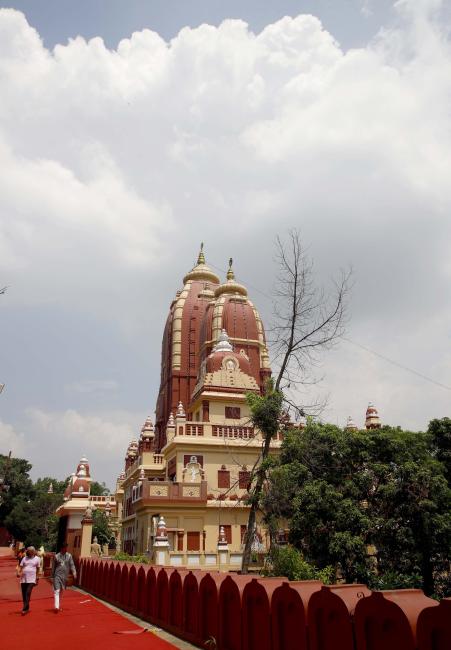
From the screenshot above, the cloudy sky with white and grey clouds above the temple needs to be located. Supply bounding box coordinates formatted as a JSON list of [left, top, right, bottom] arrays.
[[0, 0, 451, 485]]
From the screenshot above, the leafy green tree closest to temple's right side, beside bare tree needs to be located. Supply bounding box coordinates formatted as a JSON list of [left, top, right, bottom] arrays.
[[272, 422, 370, 582]]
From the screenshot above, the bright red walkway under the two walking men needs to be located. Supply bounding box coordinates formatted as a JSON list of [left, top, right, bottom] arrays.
[[0, 557, 174, 650]]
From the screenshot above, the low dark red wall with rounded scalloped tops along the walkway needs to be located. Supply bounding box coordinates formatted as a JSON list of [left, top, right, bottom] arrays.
[[79, 559, 451, 650]]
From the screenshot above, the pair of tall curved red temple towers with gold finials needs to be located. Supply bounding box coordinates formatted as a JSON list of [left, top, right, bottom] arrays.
[[154, 245, 271, 451]]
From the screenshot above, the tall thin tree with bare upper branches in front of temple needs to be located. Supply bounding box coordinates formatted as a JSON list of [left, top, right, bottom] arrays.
[[242, 230, 351, 573]]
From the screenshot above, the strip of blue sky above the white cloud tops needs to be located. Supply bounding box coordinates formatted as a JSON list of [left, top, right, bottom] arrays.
[[4, 0, 393, 48]]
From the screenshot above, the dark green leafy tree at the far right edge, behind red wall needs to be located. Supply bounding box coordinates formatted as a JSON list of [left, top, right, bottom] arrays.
[[370, 427, 451, 595]]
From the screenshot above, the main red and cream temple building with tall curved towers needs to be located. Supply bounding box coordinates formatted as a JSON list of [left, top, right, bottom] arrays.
[[117, 247, 281, 568]]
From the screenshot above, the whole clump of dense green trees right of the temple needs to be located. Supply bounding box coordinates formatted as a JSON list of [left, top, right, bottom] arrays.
[[262, 422, 451, 595]]
